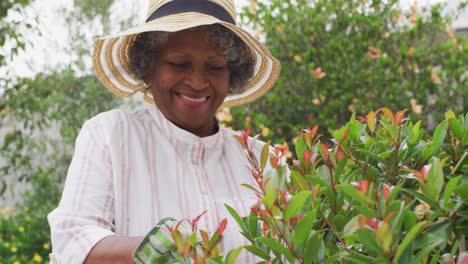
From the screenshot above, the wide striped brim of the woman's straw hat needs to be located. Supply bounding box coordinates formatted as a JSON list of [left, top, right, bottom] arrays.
[[93, 12, 280, 107]]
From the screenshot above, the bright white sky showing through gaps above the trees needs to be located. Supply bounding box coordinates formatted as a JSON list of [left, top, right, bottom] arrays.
[[0, 0, 468, 81]]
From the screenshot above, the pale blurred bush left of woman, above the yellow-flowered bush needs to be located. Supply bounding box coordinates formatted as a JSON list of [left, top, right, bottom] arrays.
[[0, 70, 119, 193]]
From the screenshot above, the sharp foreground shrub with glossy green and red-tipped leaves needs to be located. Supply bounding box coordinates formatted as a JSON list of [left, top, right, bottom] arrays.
[[228, 108, 468, 263]]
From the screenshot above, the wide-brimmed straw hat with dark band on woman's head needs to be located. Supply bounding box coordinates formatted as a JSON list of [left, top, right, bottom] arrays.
[[93, 0, 280, 107]]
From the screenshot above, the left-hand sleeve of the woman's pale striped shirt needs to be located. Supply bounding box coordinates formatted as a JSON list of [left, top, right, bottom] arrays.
[[48, 120, 115, 263]]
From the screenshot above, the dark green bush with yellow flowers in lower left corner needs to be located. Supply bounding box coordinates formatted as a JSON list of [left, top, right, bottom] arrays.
[[0, 172, 60, 263]]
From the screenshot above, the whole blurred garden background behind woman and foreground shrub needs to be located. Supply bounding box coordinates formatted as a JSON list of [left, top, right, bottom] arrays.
[[0, 0, 468, 263]]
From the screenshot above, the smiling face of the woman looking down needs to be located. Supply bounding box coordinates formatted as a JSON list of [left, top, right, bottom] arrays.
[[147, 30, 229, 137]]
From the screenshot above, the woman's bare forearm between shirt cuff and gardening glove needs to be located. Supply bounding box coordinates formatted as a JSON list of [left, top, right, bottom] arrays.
[[84, 236, 143, 264]]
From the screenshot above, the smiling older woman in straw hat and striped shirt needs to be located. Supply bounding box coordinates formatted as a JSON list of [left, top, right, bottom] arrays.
[[48, 0, 279, 263]]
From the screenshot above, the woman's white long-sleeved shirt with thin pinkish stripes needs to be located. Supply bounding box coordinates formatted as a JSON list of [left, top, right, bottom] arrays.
[[48, 105, 264, 263]]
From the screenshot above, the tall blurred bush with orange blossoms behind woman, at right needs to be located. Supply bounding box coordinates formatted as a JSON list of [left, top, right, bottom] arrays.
[[231, 0, 468, 143]]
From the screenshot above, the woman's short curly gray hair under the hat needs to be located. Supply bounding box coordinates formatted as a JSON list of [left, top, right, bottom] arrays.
[[129, 24, 254, 94]]
